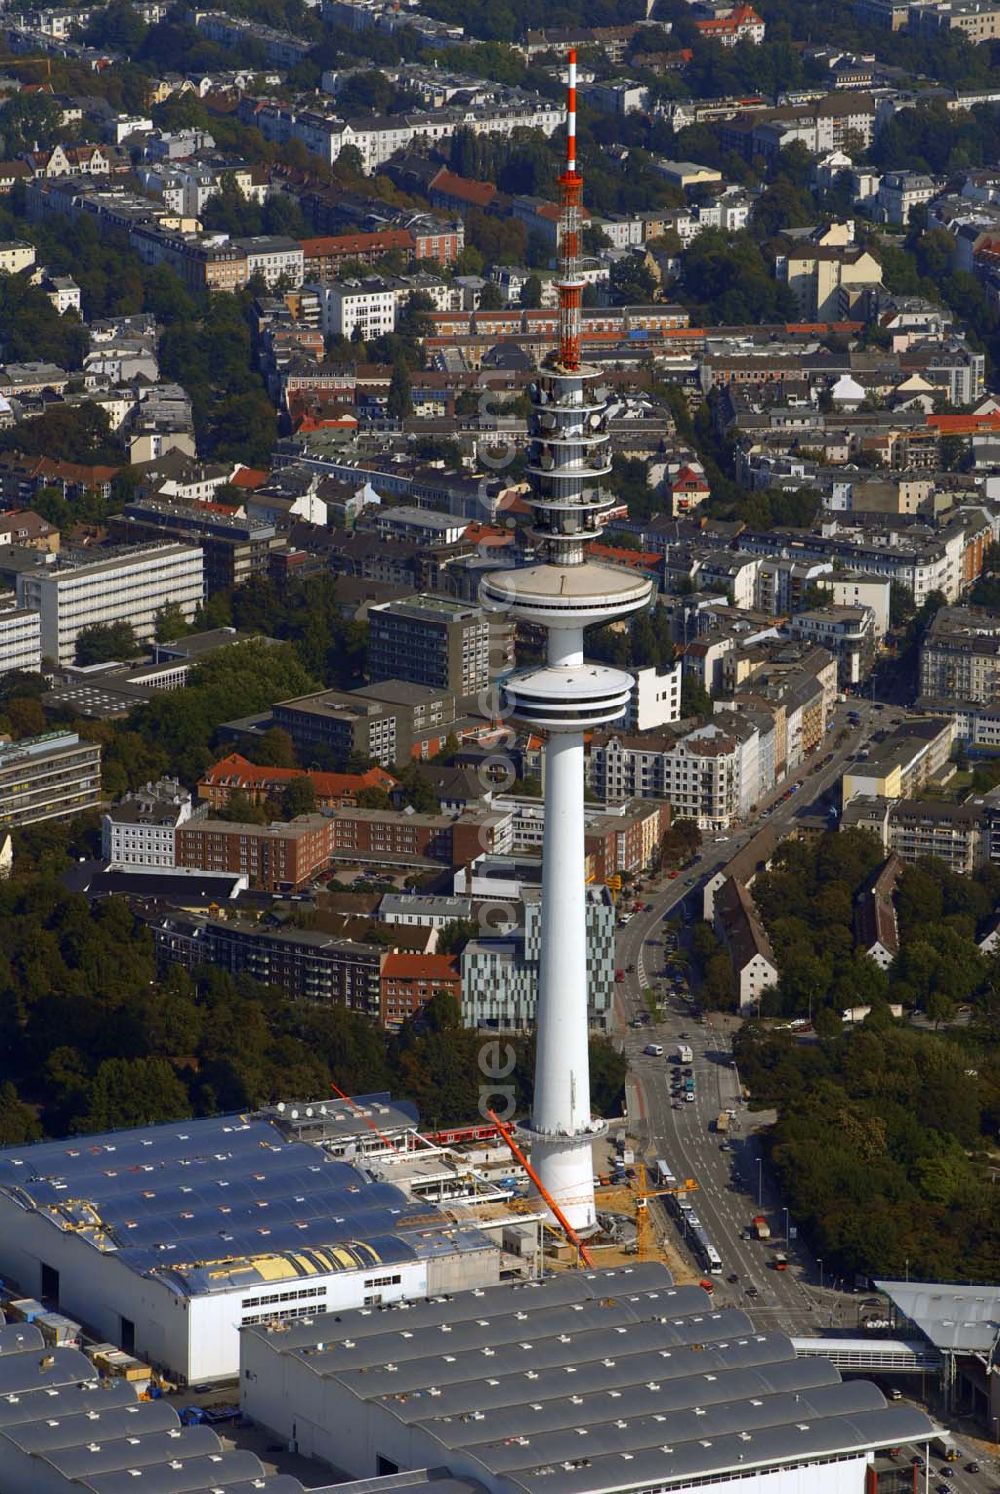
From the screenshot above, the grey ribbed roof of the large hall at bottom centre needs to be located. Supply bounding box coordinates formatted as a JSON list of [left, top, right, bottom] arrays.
[[244, 1262, 933, 1494]]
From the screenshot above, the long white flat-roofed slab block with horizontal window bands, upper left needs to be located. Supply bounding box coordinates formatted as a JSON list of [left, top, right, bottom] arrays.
[[16, 544, 205, 665]]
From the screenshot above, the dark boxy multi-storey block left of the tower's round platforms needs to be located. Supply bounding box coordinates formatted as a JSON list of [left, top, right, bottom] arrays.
[[368, 595, 513, 699]]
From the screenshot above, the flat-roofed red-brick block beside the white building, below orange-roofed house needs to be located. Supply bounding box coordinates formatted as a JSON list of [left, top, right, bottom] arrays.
[[175, 814, 333, 892]]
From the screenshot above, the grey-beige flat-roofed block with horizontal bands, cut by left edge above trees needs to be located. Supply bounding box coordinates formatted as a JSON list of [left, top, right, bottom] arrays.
[[0, 732, 102, 826]]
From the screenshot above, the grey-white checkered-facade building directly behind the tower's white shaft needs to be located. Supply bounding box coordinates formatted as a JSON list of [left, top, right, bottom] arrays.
[[462, 887, 614, 1031]]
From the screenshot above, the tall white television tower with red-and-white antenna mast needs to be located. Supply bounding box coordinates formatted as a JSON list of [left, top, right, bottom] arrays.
[[480, 51, 652, 1234]]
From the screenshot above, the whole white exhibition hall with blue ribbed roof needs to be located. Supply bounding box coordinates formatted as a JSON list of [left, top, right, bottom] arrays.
[[0, 1095, 499, 1385]]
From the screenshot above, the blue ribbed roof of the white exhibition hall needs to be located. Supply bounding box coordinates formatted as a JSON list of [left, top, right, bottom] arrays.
[[0, 1097, 489, 1302]]
